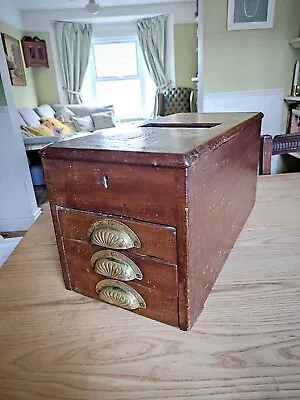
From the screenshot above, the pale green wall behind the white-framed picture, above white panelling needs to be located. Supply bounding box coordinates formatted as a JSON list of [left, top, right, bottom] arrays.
[[204, 0, 300, 94]]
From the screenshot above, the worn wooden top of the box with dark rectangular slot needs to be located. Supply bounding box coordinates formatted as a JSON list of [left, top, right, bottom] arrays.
[[40, 113, 263, 168]]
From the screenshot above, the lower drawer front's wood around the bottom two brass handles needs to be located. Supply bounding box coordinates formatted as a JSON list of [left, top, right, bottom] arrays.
[[64, 239, 178, 326]]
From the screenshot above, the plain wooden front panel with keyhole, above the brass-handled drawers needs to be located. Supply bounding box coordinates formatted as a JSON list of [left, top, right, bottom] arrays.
[[43, 159, 179, 225]]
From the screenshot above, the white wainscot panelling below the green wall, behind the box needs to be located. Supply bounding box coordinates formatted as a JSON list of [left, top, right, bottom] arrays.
[[204, 89, 284, 136]]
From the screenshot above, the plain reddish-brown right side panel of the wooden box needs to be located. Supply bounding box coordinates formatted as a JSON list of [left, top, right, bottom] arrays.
[[178, 121, 261, 328]]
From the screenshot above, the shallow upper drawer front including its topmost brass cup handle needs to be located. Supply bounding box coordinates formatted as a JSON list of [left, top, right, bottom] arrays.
[[57, 207, 177, 264]]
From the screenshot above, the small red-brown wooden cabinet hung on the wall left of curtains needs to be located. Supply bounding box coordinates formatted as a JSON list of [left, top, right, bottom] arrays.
[[22, 36, 49, 68]]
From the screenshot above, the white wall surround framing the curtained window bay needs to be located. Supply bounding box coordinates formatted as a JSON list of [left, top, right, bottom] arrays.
[[22, 0, 195, 103]]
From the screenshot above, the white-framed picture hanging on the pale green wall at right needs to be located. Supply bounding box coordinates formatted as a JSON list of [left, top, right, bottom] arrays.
[[227, 0, 275, 31]]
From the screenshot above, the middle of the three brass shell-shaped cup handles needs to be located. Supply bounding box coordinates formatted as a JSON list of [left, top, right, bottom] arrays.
[[91, 250, 143, 281]]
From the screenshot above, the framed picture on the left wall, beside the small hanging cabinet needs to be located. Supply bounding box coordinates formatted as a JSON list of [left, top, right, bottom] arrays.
[[1, 33, 27, 86]]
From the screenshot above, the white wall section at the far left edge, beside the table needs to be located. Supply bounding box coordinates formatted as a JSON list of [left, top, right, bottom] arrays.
[[0, 42, 40, 231]]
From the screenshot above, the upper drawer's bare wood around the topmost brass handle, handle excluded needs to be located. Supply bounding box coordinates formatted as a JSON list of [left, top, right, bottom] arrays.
[[57, 207, 177, 264]]
